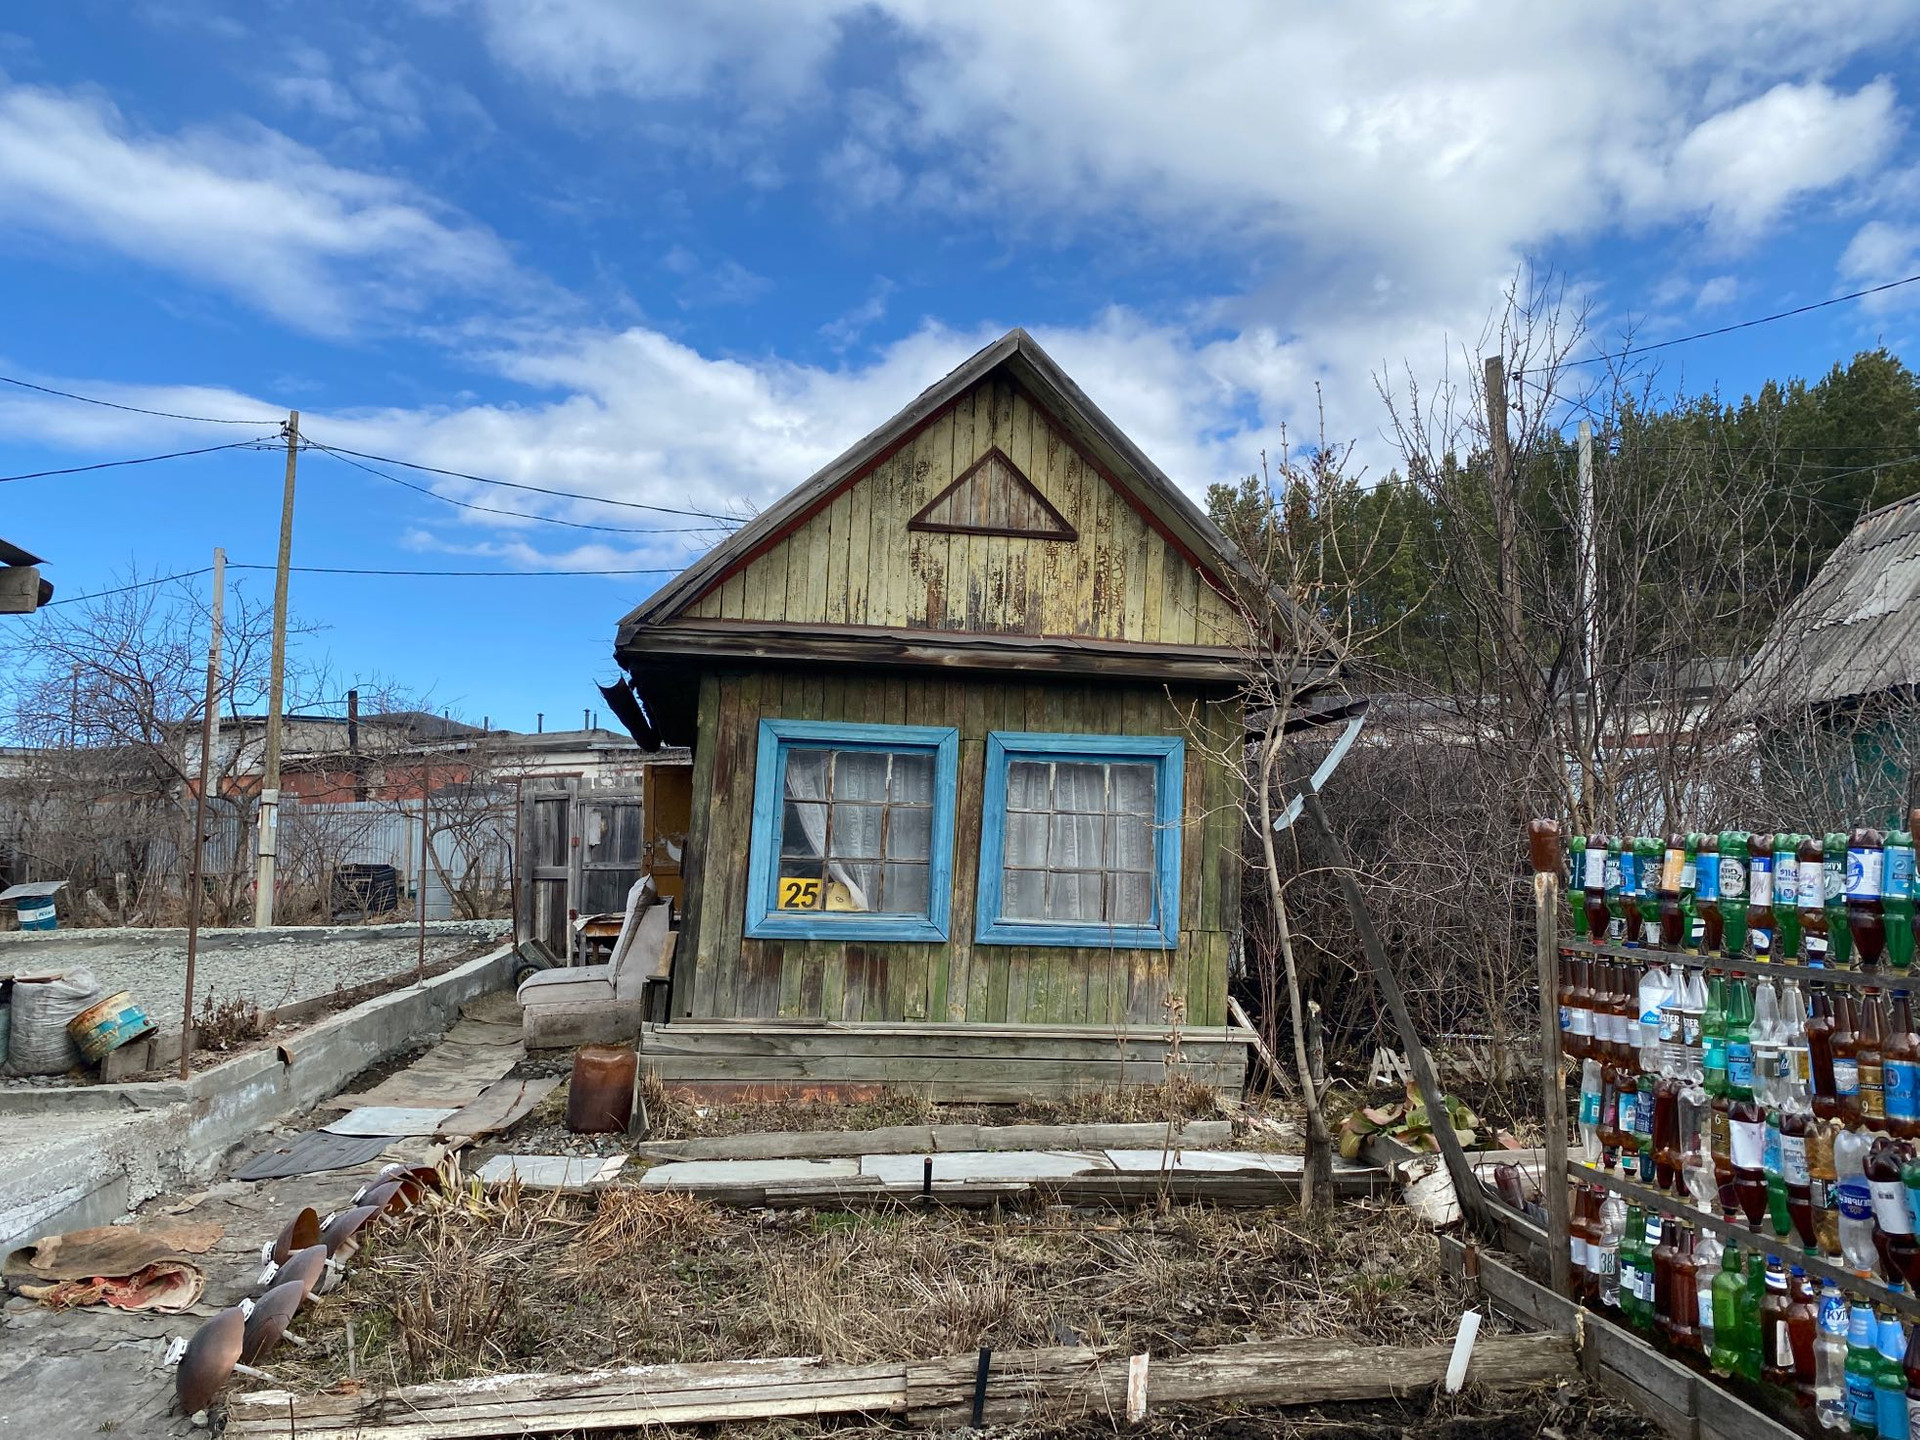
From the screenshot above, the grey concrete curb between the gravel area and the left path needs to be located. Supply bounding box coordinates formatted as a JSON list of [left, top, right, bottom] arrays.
[[0, 945, 515, 1254]]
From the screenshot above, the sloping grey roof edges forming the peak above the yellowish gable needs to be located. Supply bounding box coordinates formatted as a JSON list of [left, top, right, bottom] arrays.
[[616, 328, 1290, 647]]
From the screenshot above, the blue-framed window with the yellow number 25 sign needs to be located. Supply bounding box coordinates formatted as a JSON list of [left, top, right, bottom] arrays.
[[745, 720, 960, 941]]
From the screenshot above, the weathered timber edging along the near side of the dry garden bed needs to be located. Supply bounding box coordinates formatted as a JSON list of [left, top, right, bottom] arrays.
[[227, 1334, 1574, 1440]]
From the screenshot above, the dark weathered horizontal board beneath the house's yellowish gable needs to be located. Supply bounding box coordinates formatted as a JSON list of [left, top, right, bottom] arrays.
[[616, 620, 1244, 685]]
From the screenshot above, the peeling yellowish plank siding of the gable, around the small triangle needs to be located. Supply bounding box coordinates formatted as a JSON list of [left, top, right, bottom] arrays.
[[685, 376, 1235, 645]]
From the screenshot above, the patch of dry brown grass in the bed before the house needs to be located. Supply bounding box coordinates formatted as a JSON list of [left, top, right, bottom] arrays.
[[280, 1188, 1461, 1384]]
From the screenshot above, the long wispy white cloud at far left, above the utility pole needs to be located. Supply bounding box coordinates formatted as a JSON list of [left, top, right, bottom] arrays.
[[0, 83, 530, 334]]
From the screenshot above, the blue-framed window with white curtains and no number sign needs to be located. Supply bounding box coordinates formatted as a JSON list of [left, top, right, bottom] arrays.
[[973, 733, 1187, 950]]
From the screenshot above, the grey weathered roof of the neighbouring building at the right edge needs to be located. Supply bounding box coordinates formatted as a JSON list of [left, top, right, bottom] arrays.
[[1736, 495, 1920, 712]]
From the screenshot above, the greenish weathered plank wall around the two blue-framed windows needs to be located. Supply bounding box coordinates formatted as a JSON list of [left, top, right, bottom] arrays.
[[672, 670, 1242, 1025]]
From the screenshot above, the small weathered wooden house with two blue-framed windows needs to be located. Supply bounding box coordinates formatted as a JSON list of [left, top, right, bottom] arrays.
[[616, 330, 1282, 1098]]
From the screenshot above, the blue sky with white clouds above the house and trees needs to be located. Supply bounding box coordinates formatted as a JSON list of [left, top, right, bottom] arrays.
[[0, 0, 1920, 728]]
